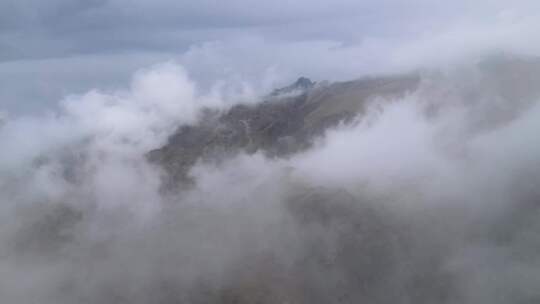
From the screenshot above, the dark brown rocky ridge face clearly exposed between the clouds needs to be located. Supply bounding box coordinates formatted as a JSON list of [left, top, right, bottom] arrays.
[[149, 75, 420, 181]]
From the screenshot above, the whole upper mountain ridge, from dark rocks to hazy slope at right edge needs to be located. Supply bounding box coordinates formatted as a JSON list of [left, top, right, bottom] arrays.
[[149, 55, 540, 182]]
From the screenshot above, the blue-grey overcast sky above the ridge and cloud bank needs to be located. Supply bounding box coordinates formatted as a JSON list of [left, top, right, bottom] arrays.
[[0, 0, 540, 113]]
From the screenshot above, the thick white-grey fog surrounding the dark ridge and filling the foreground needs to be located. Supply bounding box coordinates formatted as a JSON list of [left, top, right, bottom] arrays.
[[0, 56, 540, 303]]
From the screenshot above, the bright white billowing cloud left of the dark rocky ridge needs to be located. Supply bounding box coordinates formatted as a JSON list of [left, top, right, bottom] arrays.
[[0, 63, 226, 173]]
